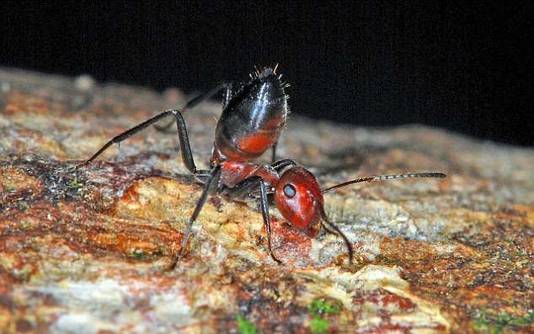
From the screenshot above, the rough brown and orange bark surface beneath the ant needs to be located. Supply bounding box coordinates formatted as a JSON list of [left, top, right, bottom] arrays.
[[0, 69, 534, 333]]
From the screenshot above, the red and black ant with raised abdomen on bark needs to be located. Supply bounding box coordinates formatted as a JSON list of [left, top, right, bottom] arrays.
[[79, 67, 445, 268]]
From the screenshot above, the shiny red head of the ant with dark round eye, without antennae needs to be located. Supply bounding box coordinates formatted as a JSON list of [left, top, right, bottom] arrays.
[[274, 166, 324, 237]]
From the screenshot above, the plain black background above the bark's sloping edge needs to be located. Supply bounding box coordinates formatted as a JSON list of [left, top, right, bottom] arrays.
[[0, 1, 534, 145]]
